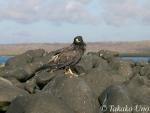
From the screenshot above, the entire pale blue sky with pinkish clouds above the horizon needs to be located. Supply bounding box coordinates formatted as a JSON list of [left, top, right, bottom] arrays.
[[0, 0, 150, 44]]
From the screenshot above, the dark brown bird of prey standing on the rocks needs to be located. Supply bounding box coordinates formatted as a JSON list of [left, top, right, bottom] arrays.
[[37, 36, 86, 75]]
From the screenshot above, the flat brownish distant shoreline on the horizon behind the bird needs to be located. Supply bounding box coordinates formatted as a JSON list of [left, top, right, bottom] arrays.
[[0, 41, 150, 56]]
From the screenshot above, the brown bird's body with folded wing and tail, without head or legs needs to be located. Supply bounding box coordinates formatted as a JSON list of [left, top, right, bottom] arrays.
[[36, 46, 81, 71]]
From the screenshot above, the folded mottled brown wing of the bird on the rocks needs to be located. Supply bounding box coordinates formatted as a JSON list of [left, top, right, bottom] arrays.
[[49, 50, 81, 69]]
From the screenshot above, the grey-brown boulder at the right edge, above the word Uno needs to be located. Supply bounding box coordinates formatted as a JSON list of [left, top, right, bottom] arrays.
[[126, 76, 150, 106]]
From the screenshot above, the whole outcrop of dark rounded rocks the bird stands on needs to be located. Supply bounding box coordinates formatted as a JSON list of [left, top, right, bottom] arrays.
[[0, 49, 150, 113]]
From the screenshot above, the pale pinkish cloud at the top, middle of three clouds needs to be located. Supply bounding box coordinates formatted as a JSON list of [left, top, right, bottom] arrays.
[[46, 0, 94, 23]]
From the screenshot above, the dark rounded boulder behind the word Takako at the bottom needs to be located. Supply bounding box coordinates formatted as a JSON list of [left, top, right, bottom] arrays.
[[99, 85, 132, 113]]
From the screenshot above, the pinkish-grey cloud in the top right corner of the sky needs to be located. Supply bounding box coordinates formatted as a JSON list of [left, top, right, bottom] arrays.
[[102, 0, 150, 26]]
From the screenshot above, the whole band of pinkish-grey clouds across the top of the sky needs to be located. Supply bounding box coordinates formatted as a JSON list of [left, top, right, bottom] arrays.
[[0, 0, 150, 26]]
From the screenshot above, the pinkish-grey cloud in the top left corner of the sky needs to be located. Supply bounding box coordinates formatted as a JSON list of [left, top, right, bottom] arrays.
[[0, 0, 40, 23]]
